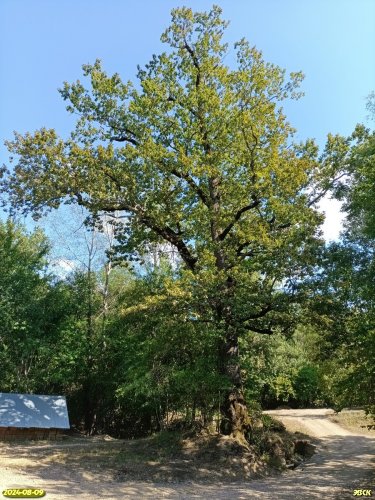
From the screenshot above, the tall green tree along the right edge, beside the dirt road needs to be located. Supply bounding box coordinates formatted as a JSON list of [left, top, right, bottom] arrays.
[[317, 115, 375, 415]]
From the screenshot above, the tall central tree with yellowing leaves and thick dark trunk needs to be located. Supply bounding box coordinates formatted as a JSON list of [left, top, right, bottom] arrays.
[[2, 7, 336, 436]]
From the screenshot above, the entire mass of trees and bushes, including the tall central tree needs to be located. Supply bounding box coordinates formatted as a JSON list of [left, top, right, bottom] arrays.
[[0, 8, 375, 437]]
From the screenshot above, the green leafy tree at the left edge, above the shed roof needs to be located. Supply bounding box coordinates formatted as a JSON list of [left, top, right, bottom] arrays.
[[0, 221, 53, 391]]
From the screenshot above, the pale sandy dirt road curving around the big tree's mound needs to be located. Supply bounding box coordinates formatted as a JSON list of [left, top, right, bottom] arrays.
[[0, 409, 375, 500]]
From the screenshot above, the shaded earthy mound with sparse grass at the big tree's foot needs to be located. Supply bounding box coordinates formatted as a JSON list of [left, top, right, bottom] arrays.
[[0, 422, 312, 482]]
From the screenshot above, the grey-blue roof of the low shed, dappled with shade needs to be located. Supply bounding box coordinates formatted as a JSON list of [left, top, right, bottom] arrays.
[[0, 392, 70, 429]]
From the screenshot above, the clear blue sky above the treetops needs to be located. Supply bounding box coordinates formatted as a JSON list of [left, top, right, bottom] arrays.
[[0, 0, 375, 242]]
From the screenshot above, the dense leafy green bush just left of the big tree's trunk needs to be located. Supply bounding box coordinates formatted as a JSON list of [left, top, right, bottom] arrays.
[[112, 271, 227, 434]]
